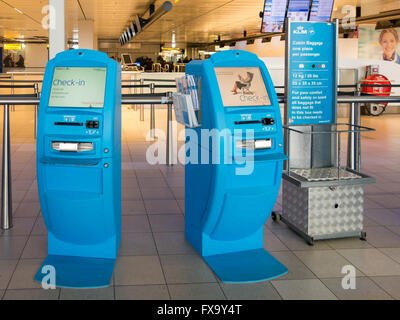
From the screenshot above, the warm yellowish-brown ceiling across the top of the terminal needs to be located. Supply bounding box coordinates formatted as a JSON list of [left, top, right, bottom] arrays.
[[0, 0, 400, 43]]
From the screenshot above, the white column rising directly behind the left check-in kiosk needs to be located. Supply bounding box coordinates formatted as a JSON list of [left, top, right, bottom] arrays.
[[49, 0, 66, 59]]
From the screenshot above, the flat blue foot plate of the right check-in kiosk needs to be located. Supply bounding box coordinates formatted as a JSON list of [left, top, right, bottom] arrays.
[[203, 249, 288, 283]]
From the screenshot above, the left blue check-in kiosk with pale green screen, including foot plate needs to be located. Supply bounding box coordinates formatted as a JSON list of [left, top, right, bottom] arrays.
[[35, 50, 121, 288]]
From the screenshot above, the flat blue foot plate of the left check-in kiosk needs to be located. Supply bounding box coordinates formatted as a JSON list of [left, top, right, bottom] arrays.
[[35, 255, 115, 289]]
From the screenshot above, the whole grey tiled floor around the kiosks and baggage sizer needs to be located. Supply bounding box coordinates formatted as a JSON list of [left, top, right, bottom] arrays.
[[0, 107, 400, 299]]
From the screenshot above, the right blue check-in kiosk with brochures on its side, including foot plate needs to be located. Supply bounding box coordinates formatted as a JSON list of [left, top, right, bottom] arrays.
[[185, 50, 287, 283]]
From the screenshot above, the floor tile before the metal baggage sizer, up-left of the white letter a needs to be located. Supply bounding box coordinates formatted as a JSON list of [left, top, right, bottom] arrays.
[[293, 250, 363, 278]]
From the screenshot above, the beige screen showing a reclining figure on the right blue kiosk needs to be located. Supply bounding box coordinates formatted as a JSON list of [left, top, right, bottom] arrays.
[[215, 67, 271, 107]]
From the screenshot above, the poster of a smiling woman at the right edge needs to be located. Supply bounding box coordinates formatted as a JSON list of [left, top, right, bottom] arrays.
[[358, 24, 400, 64]]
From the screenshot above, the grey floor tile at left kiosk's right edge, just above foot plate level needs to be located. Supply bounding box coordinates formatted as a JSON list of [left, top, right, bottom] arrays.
[[119, 233, 157, 256]]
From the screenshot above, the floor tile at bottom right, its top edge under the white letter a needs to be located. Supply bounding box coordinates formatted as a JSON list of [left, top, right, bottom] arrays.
[[321, 277, 392, 300]]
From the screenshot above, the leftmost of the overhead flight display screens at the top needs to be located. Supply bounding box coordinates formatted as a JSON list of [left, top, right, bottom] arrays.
[[261, 0, 287, 33]]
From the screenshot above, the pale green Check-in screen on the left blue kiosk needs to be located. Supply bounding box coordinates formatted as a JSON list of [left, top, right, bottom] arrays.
[[49, 67, 107, 108]]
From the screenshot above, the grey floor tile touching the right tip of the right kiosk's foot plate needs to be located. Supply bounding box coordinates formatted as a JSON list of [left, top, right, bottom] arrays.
[[270, 251, 316, 280]]
